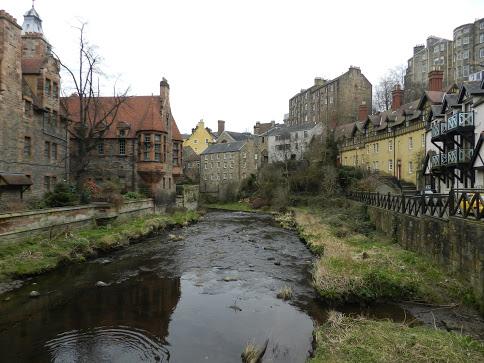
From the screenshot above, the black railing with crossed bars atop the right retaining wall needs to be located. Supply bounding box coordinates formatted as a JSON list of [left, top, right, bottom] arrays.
[[348, 189, 484, 221]]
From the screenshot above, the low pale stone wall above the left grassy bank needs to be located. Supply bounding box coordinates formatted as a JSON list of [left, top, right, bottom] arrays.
[[0, 199, 154, 243]]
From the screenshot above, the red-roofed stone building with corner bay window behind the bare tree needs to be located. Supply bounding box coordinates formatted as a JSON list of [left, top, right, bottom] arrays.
[[64, 78, 183, 196]]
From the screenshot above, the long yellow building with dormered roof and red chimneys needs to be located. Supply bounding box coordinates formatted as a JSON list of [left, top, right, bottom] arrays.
[[338, 89, 443, 186]]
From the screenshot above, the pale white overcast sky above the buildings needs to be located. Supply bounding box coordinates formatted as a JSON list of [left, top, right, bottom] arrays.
[[0, 0, 484, 132]]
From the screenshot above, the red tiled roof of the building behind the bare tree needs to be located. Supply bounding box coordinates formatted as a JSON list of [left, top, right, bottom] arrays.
[[63, 96, 183, 141]]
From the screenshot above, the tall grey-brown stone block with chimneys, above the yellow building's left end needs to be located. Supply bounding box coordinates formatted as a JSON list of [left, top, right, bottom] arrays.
[[285, 67, 372, 126]]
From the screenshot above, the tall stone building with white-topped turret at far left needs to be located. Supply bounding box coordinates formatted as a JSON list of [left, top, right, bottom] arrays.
[[0, 7, 69, 208]]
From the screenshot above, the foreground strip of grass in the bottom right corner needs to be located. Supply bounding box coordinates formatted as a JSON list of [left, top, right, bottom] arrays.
[[310, 312, 484, 363]]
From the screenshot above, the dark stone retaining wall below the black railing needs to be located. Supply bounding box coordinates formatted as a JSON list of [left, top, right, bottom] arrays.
[[367, 206, 484, 307]]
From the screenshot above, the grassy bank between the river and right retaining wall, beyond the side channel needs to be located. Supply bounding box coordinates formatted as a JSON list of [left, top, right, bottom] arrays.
[[295, 200, 473, 304]]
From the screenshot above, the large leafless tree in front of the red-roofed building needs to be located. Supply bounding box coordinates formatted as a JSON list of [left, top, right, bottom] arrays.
[[56, 23, 128, 184]]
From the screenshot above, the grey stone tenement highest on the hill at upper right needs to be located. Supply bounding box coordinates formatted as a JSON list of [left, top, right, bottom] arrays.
[[404, 18, 484, 102]]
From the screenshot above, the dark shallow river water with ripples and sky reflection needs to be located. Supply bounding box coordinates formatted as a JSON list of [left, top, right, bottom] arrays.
[[0, 212, 402, 363]]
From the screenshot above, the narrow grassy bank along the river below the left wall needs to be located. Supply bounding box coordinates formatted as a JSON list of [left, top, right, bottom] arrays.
[[0, 211, 199, 281]]
